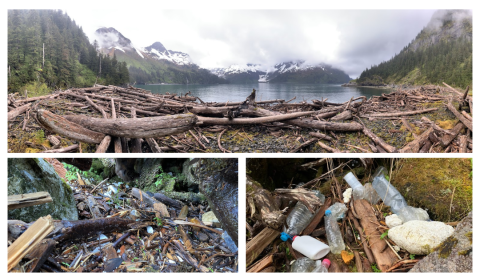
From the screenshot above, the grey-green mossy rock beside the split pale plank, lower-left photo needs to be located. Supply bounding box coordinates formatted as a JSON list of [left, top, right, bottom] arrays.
[[8, 158, 78, 222]]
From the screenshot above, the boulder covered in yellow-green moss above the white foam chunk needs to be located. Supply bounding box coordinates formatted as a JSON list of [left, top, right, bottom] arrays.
[[391, 158, 472, 222]]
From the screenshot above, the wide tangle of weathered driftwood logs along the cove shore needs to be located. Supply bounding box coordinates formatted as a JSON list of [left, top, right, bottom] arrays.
[[8, 84, 473, 153]]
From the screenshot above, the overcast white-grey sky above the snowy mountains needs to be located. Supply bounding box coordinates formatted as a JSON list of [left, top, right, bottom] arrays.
[[66, 8, 434, 77]]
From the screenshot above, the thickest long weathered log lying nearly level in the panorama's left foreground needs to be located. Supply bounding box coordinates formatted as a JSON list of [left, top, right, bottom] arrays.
[[65, 113, 197, 138]]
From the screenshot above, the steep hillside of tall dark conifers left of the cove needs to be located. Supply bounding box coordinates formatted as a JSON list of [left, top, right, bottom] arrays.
[[8, 10, 129, 92]]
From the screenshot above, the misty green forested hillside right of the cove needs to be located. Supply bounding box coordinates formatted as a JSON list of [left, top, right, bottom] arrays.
[[358, 10, 472, 87]]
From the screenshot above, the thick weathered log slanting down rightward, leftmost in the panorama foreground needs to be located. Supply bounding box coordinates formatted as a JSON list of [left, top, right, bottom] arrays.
[[36, 109, 105, 144]]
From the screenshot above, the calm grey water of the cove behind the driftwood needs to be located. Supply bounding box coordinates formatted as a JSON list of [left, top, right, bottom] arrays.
[[136, 83, 391, 103]]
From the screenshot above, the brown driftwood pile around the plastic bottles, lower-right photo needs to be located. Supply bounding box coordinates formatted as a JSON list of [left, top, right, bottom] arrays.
[[246, 158, 442, 272]]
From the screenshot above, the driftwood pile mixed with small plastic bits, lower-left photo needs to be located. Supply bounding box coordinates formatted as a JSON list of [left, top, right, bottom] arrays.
[[8, 160, 238, 273]]
